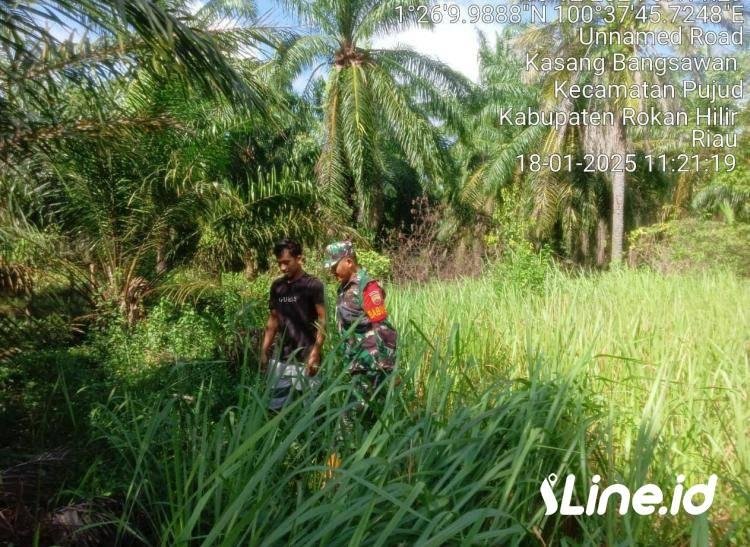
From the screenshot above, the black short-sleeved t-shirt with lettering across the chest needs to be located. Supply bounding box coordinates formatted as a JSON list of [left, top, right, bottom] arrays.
[[268, 274, 324, 361]]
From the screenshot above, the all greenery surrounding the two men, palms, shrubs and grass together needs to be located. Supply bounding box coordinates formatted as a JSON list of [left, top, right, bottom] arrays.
[[0, 0, 750, 545]]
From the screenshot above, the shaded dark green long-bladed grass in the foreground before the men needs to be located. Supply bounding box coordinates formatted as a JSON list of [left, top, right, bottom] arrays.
[[82, 340, 591, 545]]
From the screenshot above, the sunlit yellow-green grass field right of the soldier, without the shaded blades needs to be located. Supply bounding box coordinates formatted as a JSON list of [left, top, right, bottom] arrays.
[[391, 270, 750, 544]]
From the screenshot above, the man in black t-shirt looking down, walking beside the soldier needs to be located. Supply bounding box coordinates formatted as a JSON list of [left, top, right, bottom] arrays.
[[260, 239, 326, 410]]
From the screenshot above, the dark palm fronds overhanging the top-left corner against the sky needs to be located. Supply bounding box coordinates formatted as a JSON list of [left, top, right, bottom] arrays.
[[0, 0, 280, 169]]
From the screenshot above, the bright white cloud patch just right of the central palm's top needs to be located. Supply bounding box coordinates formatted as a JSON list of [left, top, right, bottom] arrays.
[[373, 23, 502, 82]]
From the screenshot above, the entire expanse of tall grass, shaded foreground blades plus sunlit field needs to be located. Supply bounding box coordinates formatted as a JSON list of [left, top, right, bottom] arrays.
[[72, 271, 750, 545]]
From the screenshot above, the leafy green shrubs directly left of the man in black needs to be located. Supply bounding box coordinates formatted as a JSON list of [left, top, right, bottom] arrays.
[[91, 271, 273, 381]]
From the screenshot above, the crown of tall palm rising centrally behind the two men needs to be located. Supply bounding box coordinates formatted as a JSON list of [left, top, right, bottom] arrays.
[[281, 0, 470, 229]]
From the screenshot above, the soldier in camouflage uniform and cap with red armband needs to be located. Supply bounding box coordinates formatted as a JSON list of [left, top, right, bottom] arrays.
[[325, 241, 397, 425]]
